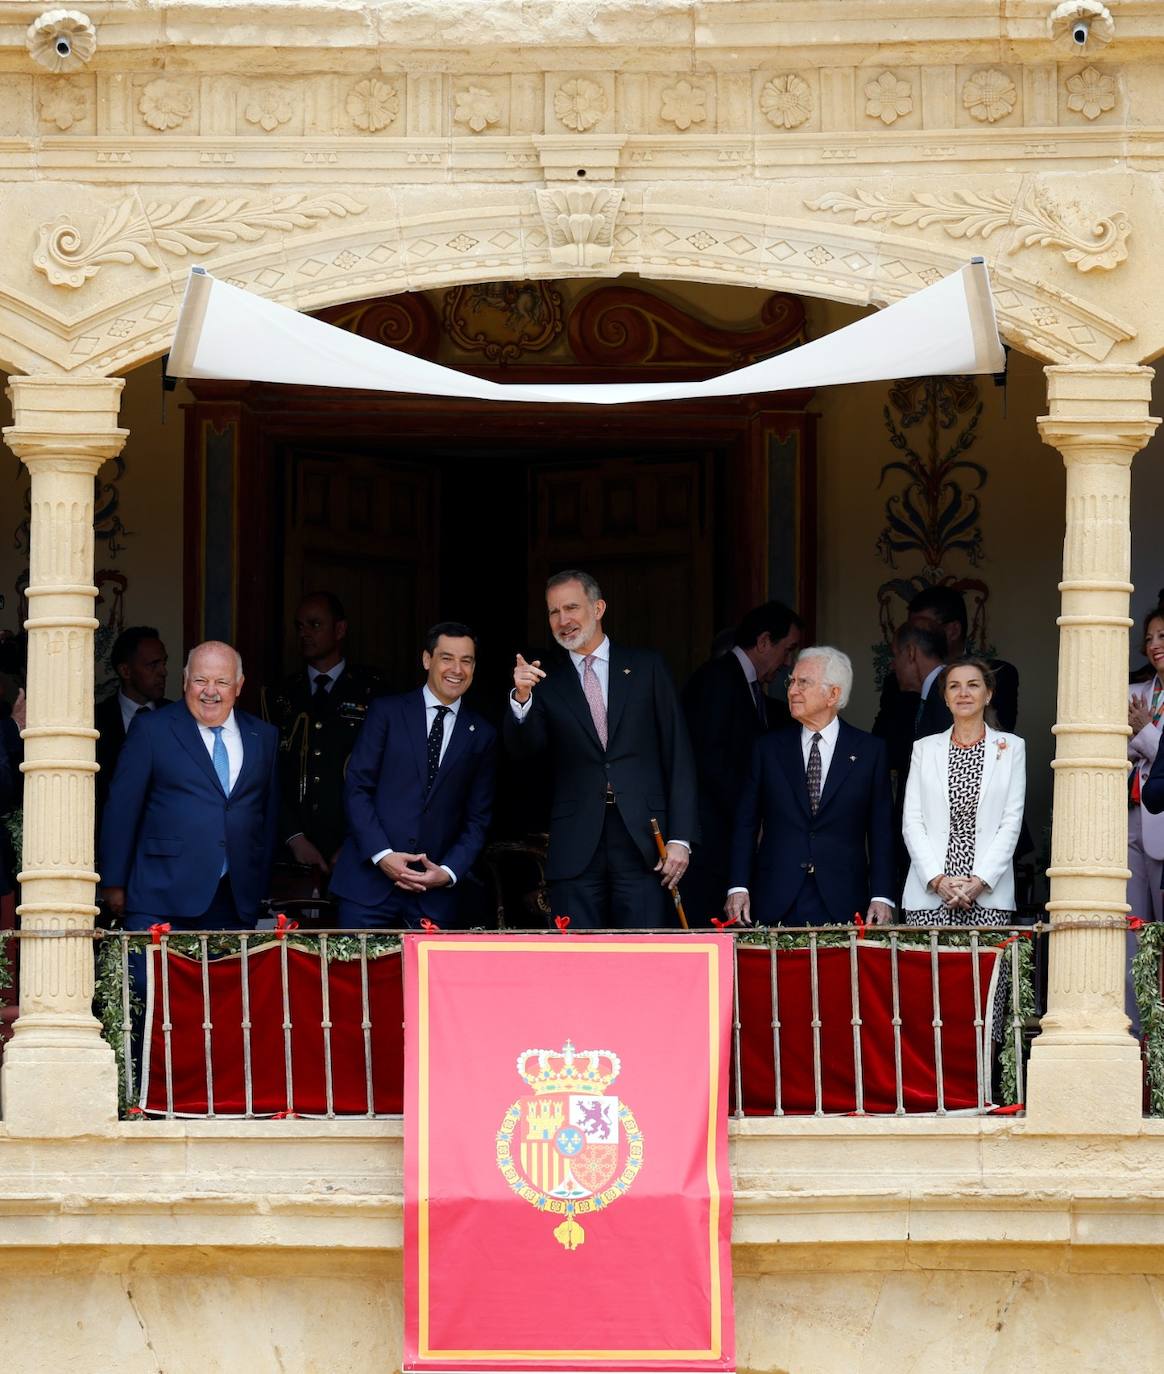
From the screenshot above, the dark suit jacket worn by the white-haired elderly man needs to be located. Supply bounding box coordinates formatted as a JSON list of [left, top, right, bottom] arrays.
[[730, 720, 896, 923]]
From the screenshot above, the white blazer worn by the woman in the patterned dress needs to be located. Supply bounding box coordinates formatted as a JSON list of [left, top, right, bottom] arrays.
[[902, 725, 1027, 911]]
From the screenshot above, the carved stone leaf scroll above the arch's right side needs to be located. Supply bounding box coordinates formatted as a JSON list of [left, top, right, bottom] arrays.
[[804, 185, 1131, 272]]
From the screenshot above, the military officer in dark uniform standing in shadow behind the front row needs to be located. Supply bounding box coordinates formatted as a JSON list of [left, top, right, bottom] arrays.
[[262, 592, 386, 874]]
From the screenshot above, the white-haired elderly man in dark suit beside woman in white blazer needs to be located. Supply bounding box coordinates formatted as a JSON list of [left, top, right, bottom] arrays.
[[724, 646, 893, 926]]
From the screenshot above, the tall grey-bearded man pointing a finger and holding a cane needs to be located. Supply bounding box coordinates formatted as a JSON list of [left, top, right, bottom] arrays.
[[502, 570, 699, 929]]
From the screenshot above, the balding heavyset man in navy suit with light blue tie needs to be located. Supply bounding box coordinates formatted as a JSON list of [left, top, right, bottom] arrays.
[[100, 640, 279, 930]]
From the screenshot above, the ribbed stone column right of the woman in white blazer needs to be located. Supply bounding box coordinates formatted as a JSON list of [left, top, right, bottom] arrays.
[[1027, 365, 1160, 1132]]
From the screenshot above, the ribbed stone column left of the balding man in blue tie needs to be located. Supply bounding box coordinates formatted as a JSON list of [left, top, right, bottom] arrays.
[[0, 376, 126, 1136]]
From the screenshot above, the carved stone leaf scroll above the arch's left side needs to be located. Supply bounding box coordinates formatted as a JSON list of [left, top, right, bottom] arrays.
[[33, 194, 367, 289]]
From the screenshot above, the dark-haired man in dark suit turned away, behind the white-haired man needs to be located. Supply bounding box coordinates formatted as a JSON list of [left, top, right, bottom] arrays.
[[682, 600, 804, 926]]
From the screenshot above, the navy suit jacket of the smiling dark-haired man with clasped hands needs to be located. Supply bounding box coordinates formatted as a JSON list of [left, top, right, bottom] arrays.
[[330, 688, 497, 923]]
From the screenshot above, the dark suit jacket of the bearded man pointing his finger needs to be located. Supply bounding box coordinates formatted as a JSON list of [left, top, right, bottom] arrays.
[[502, 642, 699, 881]]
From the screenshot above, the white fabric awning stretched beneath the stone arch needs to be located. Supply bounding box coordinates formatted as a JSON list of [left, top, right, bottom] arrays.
[[168, 258, 1006, 405]]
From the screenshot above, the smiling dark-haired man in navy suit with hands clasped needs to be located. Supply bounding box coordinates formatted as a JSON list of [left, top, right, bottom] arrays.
[[330, 621, 497, 930]]
